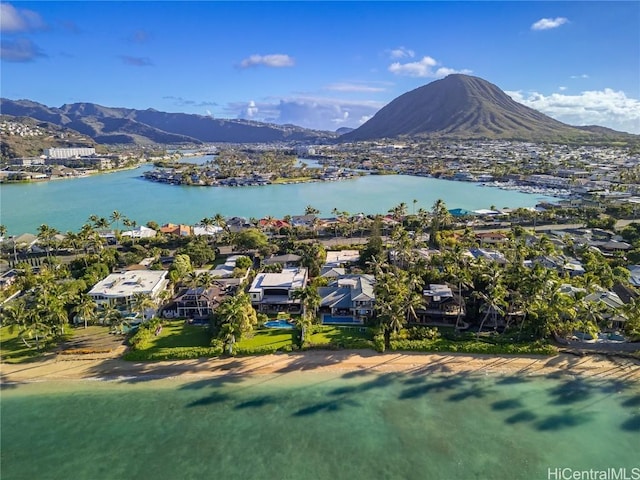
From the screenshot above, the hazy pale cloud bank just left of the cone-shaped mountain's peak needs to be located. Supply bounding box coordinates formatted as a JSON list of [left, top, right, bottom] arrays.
[[225, 97, 384, 131]]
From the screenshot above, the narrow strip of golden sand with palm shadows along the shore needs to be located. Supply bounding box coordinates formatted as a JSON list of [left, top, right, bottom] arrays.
[[1, 350, 640, 383]]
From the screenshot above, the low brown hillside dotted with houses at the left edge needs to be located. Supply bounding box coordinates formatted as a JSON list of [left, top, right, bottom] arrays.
[[0, 115, 97, 158]]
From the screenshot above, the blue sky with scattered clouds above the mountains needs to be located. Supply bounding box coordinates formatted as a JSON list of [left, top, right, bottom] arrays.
[[0, 1, 640, 133]]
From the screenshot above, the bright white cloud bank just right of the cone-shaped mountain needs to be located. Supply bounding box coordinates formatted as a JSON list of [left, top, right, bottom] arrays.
[[507, 88, 640, 134]]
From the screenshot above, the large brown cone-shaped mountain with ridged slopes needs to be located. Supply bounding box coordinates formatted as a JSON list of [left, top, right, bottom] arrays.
[[340, 74, 637, 142]]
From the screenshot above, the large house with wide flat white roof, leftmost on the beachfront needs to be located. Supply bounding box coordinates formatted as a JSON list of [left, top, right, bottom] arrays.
[[89, 270, 168, 318]]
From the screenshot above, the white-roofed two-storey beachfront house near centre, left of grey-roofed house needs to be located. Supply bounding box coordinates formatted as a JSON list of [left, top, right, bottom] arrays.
[[249, 268, 308, 313]]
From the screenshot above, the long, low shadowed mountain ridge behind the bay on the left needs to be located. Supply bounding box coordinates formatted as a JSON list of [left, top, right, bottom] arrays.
[[0, 98, 337, 144]]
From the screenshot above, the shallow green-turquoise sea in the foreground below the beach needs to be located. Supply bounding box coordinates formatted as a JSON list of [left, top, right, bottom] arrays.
[[0, 372, 640, 480]]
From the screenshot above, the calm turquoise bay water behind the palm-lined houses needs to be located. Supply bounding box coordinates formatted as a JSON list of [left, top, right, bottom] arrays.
[[0, 166, 549, 235]]
